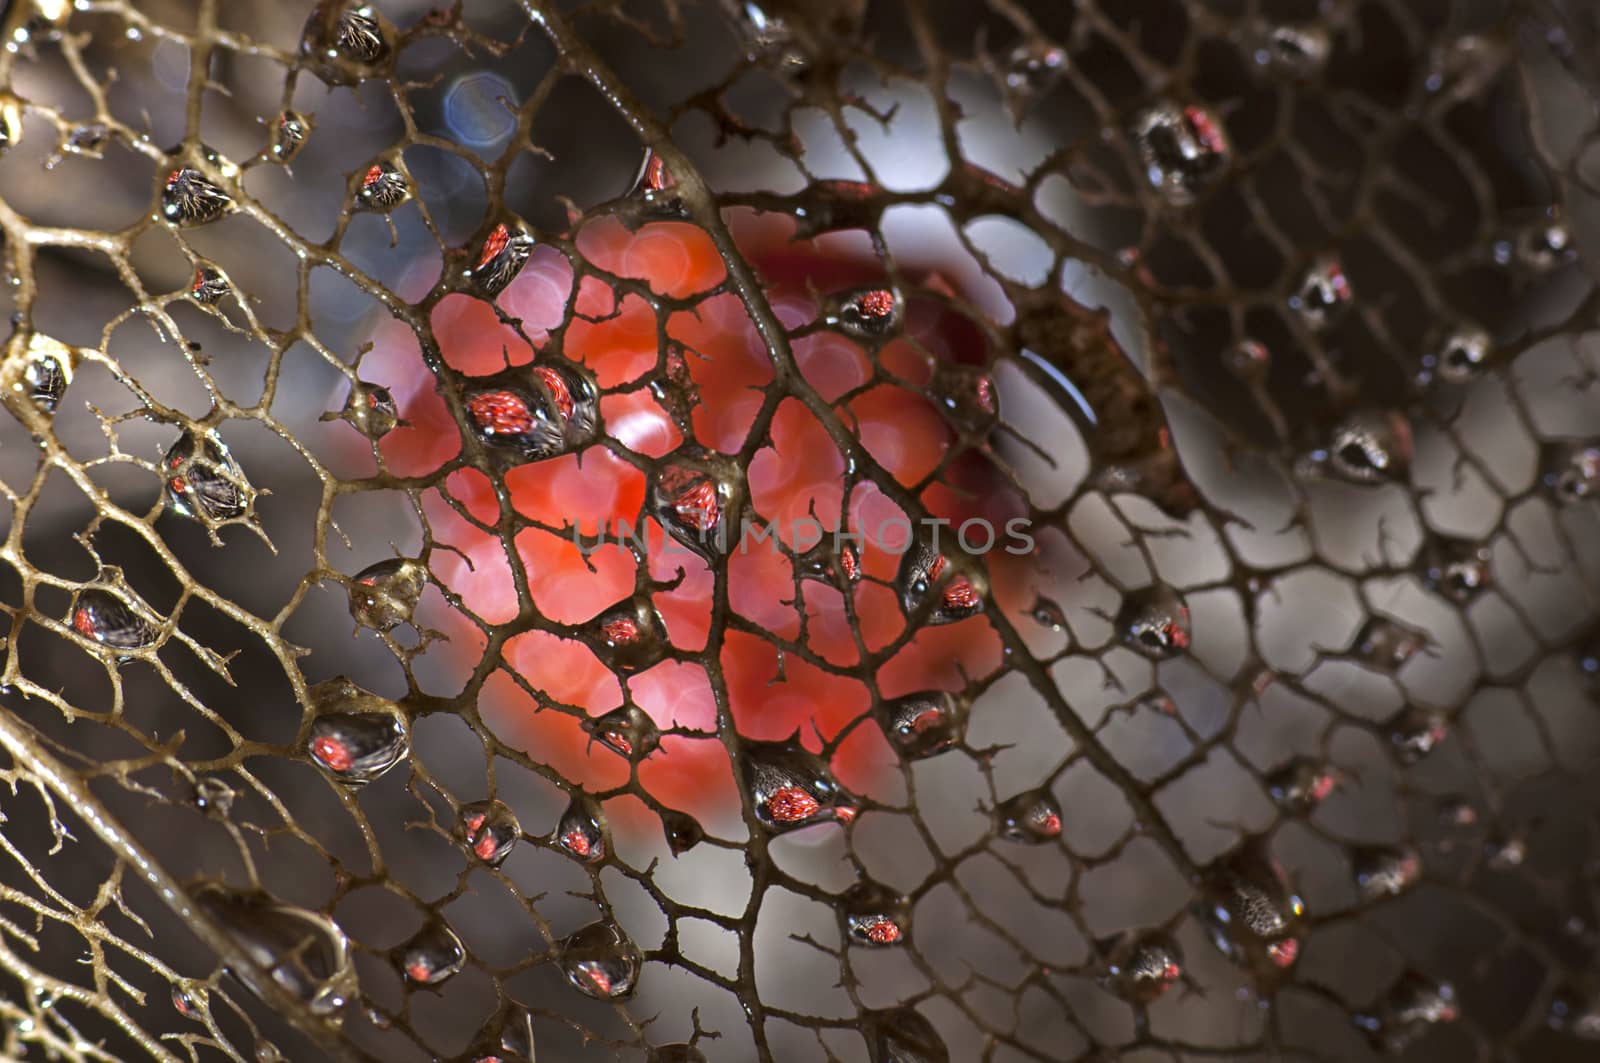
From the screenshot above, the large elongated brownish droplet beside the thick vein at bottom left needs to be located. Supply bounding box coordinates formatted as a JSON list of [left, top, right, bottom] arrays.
[[192, 882, 358, 1021]]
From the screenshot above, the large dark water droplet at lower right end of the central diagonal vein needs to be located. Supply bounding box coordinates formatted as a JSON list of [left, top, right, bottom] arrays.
[[1194, 839, 1306, 981]]
